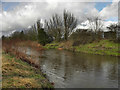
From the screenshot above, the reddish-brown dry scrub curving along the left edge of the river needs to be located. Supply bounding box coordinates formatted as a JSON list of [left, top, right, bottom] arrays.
[[2, 40, 44, 68]]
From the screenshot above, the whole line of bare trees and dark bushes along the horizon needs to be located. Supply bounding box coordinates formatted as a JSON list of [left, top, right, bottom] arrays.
[[2, 10, 120, 45]]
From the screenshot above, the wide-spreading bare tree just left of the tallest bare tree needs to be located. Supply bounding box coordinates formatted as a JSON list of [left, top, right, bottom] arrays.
[[45, 14, 63, 41]]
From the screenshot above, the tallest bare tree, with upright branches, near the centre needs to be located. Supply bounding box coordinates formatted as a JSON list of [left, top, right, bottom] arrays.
[[63, 10, 77, 40]]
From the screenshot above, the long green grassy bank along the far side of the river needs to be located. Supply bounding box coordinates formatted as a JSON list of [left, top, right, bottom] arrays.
[[44, 40, 120, 56]]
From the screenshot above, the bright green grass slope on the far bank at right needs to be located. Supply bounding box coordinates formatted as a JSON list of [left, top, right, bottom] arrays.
[[76, 40, 120, 56]]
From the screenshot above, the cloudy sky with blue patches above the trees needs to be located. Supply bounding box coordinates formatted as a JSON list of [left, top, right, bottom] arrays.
[[0, 0, 119, 35]]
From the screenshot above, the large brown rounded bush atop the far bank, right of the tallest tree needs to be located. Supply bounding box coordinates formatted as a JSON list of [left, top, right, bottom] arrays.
[[69, 29, 101, 46]]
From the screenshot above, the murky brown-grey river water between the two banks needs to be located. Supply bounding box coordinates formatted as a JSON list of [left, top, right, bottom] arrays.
[[20, 48, 118, 88]]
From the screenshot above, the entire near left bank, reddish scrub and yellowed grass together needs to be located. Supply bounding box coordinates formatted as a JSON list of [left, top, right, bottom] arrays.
[[2, 40, 52, 88]]
